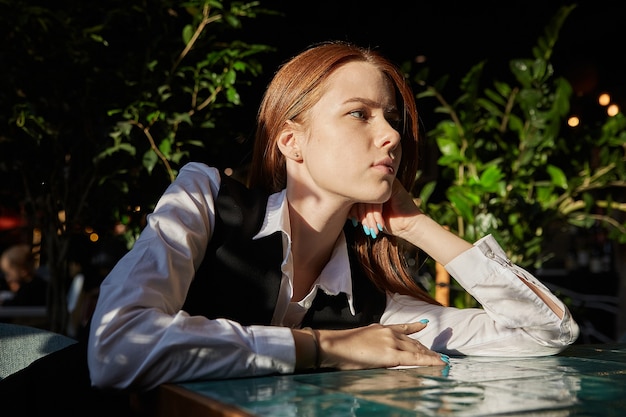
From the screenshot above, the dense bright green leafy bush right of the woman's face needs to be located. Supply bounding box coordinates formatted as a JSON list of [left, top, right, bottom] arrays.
[[408, 6, 626, 304]]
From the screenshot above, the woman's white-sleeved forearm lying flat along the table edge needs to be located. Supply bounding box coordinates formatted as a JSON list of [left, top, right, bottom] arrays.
[[88, 310, 294, 389]]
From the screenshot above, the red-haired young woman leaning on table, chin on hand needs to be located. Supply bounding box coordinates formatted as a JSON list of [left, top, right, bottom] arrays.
[[88, 42, 579, 389]]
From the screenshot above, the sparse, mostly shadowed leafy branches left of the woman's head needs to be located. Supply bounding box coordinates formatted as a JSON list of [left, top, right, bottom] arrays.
[[0, 0, 270, 330]]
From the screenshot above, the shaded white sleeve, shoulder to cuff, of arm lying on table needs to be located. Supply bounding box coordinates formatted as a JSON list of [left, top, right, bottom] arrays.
[[88, 163, 295, 389]]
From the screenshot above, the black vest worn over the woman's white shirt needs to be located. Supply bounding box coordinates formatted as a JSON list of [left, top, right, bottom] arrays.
[[183, 175, 386, 329]]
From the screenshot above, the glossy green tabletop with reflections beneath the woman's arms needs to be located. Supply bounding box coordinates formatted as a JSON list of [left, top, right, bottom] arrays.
[[151, 344, 626, 417]]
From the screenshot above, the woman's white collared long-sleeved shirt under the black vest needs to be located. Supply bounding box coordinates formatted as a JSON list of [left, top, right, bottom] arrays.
[[88, 163, 579, 388]]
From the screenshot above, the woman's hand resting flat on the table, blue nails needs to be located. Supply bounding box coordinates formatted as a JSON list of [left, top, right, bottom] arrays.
[[300, 322, 449, 370]]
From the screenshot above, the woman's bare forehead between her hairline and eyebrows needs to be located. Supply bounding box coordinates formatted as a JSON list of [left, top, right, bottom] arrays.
[[324, 62, 395, 105]]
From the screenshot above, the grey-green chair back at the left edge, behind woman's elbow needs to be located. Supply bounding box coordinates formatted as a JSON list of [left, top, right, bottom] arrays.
[[0, 323, 76, 379]]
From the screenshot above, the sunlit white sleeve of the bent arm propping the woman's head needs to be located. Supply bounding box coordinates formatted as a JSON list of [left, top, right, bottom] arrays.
[[381, 236, 579, 357]]
